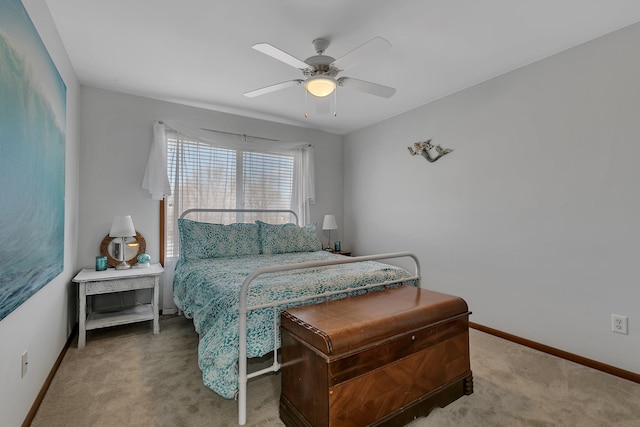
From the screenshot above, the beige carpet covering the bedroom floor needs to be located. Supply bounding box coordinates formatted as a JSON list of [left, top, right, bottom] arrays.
[[32, 316, 640, 427]]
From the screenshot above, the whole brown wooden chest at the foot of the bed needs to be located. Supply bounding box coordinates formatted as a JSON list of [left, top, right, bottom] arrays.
[[280, 286, 473, 427]]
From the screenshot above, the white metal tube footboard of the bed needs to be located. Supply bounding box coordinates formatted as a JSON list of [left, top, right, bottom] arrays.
[[238, 252, 420, 425]]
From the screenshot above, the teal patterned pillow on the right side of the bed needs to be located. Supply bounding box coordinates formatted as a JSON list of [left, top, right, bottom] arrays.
[[256, 221, 322, 254]]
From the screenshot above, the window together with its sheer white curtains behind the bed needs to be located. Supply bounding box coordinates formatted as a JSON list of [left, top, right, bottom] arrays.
[[142, 122, 315, 313]]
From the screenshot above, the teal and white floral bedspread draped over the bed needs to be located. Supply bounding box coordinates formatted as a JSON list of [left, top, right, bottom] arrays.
[[173, 251, 411, 399]]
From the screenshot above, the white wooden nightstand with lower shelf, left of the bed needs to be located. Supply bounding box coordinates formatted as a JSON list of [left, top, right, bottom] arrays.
[[73, 264, 164, 348]]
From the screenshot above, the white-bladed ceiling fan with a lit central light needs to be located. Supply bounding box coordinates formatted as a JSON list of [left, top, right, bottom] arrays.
[[244, 37, 396, 98]]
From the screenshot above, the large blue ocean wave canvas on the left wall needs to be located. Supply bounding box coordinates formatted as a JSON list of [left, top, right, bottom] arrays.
[[0, 0, 67, 320]]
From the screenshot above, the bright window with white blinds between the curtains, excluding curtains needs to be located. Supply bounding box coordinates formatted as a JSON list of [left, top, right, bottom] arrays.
[[165, 129, 294, 258]]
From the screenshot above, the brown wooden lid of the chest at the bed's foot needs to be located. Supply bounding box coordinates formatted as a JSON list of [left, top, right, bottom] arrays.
[[280, 286, 468, 356]]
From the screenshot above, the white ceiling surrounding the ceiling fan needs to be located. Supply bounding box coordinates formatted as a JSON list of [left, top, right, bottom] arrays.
[[45, 0, 640, 134]]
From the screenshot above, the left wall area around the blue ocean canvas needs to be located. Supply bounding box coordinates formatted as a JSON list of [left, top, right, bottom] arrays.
[[0, 0, 79, 426]]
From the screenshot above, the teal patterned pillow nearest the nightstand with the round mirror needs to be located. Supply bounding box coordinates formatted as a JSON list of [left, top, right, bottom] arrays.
[[178, 219, 260, 260]]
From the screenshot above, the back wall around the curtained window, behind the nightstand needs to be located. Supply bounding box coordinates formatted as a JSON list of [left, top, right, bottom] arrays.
[[78, 86, 343, 307]]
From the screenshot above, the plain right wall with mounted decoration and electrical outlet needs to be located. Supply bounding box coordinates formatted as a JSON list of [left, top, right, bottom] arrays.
[[344, 25, 640, 373]]
